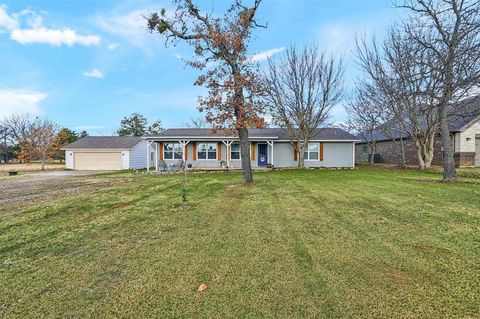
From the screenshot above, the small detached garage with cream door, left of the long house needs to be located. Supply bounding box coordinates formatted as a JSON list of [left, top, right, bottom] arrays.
[[62, 136, 154, 170]]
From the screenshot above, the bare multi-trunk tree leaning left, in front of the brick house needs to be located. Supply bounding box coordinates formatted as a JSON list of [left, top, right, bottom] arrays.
[[357, 28, 438, 169]]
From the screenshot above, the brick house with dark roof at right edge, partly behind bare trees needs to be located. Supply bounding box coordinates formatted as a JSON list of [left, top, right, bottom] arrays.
[[355, 116, 480, 167]]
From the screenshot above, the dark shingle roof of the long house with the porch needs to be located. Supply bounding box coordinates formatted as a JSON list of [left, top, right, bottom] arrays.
[[149, 128, 358, 141]]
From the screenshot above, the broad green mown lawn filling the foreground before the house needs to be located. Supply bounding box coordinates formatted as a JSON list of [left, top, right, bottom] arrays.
[[0, 168, 480, 318]]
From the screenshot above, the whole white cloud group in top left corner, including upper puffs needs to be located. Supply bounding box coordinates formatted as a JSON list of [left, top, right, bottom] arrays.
[[0, 5, 101, 47]]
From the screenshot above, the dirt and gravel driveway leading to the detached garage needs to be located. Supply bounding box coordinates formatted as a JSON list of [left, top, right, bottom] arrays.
[[0, 171, 119, 213]]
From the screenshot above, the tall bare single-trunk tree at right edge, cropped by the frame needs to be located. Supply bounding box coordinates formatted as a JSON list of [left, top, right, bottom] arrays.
[[397, 0, 480, 181]]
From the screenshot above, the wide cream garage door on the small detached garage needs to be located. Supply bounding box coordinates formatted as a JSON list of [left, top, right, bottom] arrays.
[[73, 152, 122, 171]]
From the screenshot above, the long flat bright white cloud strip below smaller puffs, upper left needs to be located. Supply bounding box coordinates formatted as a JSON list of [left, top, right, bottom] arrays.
[[10, 27, 101, 47]]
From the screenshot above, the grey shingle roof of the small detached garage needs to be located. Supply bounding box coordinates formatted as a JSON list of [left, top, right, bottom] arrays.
[[63, 136, 142, 149]]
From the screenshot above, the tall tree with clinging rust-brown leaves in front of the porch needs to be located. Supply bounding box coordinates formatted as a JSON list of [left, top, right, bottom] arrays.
[[148, 0, 264, 183]]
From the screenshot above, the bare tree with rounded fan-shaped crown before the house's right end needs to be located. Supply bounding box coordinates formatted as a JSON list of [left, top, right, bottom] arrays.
[[264, 44, 344, 167]]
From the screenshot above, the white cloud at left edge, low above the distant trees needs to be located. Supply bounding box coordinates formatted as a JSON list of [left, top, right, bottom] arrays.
[[0, 88, 47, 119]]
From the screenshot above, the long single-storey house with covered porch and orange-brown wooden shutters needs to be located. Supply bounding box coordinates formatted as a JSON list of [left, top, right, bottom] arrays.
[[145, 128, 358, 169]]
